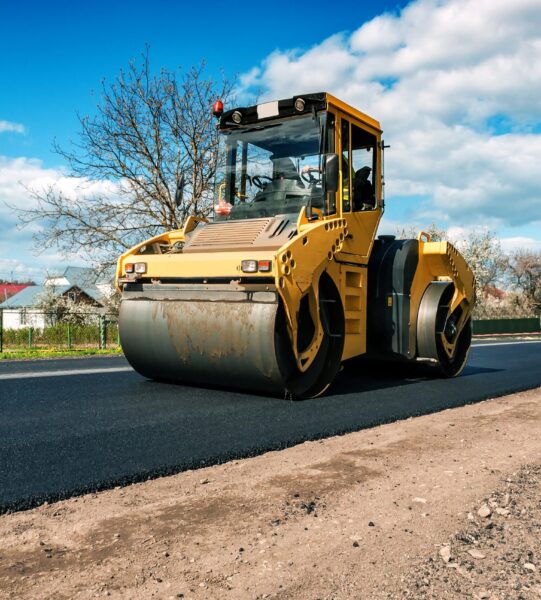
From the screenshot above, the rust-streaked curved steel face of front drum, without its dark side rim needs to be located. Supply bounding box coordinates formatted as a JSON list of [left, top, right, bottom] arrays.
[[119, 296, 284, 394]]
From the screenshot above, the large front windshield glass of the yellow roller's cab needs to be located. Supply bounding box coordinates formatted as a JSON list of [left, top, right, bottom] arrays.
[[215, 115, 326, 220]]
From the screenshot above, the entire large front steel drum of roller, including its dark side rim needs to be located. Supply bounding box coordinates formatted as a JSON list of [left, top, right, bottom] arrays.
[[119, 277, 343, 398]]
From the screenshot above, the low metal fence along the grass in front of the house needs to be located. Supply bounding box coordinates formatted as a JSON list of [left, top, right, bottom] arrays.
[[0, 309, 120, 352]]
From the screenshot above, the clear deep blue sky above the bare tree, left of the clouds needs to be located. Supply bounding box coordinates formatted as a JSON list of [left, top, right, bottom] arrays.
[[0, 0, 406, 166]]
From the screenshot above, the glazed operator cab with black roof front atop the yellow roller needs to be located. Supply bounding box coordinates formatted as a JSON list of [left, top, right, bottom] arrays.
[[215, 93, 381, 226]]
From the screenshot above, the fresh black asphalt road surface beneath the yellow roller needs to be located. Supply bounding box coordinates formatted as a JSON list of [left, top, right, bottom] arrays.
[[0, 341, 541, 513]]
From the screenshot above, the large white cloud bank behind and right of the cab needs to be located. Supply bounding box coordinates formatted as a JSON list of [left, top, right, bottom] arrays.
[[240, 0, 541, 243]]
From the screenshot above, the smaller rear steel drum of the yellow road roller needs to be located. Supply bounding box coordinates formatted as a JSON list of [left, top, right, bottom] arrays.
[[417, 281, 472, 377]]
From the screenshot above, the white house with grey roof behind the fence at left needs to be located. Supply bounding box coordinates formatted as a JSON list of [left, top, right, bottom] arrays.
[[0, 267, 112, 329]]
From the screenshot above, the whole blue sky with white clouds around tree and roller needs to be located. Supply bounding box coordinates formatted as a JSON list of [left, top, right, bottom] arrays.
[[0, 0, 541, 279]]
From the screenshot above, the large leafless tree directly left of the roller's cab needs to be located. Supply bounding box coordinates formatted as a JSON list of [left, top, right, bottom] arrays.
[[14, 51, 233, 263]]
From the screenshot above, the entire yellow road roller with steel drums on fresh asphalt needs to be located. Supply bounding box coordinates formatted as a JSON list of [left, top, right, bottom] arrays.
[[116, 93, 475, 399]]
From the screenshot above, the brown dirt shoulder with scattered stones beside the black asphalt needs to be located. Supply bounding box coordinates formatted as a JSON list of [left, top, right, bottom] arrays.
[[0, 389, 541, 600]]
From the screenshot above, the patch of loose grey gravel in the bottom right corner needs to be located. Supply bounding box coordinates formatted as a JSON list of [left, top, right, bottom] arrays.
[[387, 464, 541, 600]]
